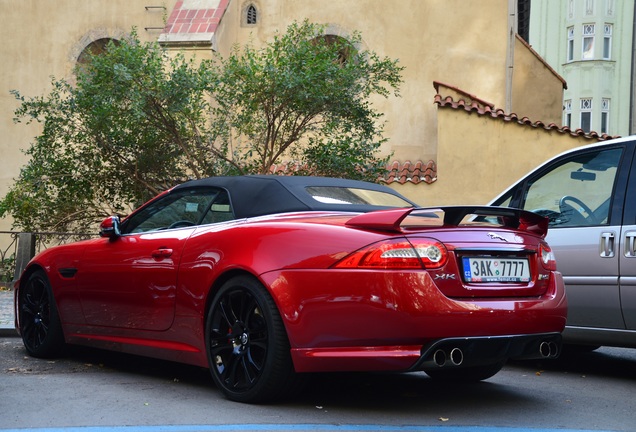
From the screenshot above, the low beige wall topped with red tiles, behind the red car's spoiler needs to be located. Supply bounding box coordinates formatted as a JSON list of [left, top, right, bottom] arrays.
[[430, 107, 596, 205]]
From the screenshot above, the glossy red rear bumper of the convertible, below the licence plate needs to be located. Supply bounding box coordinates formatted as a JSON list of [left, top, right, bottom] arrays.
[[263, 270, 567, 372]]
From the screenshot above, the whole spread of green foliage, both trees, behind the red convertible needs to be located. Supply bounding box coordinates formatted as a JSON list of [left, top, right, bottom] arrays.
[[0, 22, 402, 231]]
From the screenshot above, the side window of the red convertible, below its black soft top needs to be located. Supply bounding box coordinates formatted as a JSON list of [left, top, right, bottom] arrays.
[[122, 188, 232, 234]]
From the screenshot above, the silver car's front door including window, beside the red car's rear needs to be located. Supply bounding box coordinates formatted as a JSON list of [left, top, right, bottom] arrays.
[[523, 147, 625, 329]]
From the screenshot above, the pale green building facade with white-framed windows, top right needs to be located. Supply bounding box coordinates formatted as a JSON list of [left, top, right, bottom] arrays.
[[529, 0, 635, 136]]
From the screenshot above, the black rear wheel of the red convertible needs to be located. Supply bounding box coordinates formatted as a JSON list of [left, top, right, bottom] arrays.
[[205, 276, 299, 403]]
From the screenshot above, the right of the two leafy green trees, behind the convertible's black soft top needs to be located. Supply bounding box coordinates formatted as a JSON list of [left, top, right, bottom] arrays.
[[213, 21, 402, 177]]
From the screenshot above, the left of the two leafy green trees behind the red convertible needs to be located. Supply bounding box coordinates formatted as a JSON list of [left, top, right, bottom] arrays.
[[0, 32, 228, 232]]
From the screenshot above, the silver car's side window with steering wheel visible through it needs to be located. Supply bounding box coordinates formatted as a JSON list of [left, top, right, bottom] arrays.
[[522, 149, 623, 228]]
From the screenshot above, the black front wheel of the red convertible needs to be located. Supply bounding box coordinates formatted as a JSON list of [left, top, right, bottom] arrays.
[[18, 270, 65, 358]]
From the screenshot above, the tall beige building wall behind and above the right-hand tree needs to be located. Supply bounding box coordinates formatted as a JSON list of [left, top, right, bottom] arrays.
[[217, 0, 508, 161]]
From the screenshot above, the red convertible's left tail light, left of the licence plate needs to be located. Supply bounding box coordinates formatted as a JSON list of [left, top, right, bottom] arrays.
[[334, 238, 448, 269]]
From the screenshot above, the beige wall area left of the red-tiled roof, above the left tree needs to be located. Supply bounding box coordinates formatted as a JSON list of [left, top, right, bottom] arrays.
[[0, 0, 176, 231]]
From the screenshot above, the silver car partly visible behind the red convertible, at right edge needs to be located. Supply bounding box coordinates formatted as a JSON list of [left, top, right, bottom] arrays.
[[491, 136, 636, 349]]
